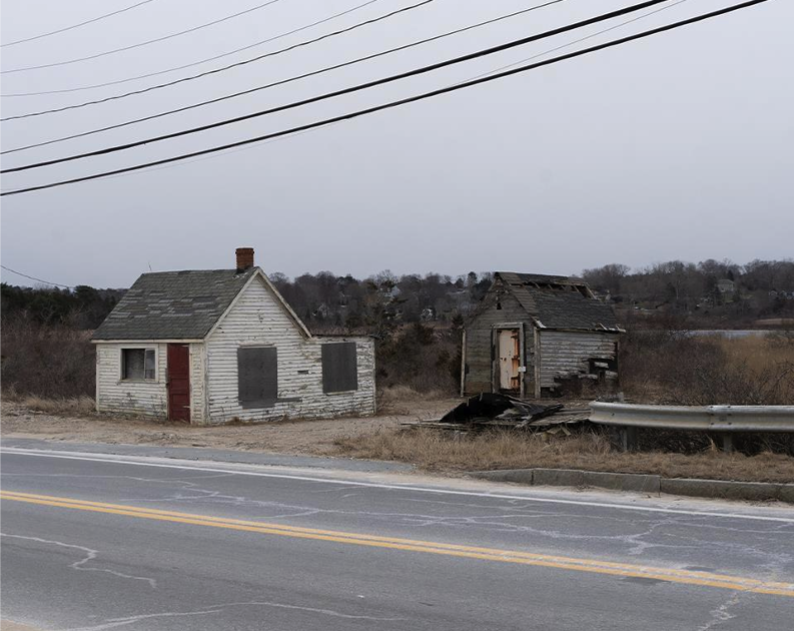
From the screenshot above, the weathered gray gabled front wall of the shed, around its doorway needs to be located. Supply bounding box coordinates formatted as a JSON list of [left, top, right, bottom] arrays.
[[464, 283, 535, 395]]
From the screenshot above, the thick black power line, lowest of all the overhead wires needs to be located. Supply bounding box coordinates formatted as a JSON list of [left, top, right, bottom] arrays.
[[0, 0, 769, 196]]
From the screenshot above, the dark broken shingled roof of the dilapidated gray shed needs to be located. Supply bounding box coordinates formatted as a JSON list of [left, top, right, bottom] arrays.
[[495, 272, 621, 331]]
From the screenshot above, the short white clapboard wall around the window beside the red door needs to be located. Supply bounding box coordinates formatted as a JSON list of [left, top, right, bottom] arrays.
[[96, 342, 168, 418]]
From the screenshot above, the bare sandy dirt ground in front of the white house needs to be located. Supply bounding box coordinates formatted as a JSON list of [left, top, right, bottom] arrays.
[[0, 399, 459, 456]]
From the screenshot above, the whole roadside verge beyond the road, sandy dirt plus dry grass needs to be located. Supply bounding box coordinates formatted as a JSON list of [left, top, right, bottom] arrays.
[[0, 393, 794, 482]]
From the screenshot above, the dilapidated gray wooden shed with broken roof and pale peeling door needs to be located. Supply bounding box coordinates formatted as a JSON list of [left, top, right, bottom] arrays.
[[461, 272, 622, 397]]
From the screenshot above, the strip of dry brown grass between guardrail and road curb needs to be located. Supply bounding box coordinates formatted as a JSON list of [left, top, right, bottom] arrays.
[[336, 428, 794, 482]]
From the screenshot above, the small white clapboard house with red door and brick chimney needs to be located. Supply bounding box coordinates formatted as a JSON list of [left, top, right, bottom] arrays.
[[93, 248, 375, 425]]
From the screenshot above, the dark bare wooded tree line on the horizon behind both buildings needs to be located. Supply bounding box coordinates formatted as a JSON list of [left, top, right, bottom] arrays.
[[0, 259, 794, 336]]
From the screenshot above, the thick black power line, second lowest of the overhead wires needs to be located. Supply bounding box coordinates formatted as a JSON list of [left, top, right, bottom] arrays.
[[0, 0, 668, 173]]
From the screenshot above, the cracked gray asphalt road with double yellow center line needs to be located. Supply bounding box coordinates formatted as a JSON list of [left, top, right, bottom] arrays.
[[0, 451, 794, 631]]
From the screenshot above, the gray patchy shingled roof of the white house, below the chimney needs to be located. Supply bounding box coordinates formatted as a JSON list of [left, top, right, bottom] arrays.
[[93, 267, 259, 340]]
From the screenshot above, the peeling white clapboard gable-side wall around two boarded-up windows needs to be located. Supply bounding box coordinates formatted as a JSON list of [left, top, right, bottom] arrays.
[[201, 277, 375, 424]]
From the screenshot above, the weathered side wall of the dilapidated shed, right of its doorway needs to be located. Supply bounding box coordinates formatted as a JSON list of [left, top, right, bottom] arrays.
[[540, 330, 618, 388]]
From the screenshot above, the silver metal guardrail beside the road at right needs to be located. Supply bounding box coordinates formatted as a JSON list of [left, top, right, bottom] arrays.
[[590, 401, 794, 432]]
